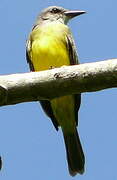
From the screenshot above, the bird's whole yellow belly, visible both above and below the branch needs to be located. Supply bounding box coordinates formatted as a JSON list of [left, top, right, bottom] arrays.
[[31, 23, 75, 131]]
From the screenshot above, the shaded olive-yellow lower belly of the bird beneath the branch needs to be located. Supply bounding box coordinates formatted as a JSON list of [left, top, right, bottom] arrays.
[[51, 95, 76, 132]]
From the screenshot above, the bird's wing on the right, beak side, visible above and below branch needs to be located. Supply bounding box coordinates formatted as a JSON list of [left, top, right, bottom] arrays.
[[66, 32, 81, 125]]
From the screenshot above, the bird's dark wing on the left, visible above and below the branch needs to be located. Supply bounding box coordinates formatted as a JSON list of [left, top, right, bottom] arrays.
[[26, 31, 58, 130]]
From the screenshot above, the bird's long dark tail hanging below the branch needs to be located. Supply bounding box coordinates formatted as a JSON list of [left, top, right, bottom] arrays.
[[63, 129, 85, 176]]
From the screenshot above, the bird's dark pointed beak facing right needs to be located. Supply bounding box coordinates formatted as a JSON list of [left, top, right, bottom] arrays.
[[64, 10, 86, 19]]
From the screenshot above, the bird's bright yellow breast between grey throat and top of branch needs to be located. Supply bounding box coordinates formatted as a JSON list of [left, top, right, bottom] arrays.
[[31, 24, 70, 71]]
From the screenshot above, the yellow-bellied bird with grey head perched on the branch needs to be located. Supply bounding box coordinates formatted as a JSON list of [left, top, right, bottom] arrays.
[[26, 6, 85, 176]]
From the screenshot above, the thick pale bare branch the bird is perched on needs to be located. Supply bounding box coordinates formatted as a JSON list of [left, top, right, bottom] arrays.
[[0, 59, 117, 106]]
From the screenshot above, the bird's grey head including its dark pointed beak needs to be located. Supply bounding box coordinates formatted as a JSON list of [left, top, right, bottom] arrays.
[[36, 6, 85, 24]]
